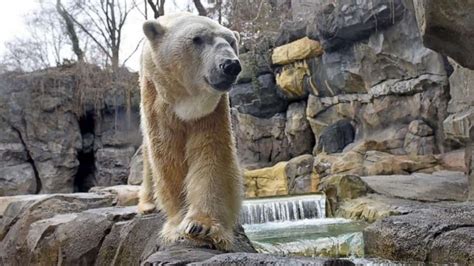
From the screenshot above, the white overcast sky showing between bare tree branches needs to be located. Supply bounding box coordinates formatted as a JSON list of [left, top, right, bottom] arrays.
[[0, 0, 202, 70]]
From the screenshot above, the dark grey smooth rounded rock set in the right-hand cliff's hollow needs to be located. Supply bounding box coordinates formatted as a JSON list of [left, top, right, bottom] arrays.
[[316, 119, 355, 153]]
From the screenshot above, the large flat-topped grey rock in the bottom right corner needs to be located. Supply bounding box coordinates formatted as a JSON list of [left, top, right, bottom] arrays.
[[364, 203, 474, 265]]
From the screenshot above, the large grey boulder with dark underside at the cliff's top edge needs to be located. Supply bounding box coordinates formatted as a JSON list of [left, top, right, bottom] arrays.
[[316, 0, 406, 51]]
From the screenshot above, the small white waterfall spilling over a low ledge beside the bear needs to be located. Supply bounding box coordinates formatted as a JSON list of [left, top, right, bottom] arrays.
[[240, 195, 326, 224]]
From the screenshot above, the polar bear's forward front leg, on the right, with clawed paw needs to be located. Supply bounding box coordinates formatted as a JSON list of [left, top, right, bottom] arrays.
[[179, 98, 242, 250]]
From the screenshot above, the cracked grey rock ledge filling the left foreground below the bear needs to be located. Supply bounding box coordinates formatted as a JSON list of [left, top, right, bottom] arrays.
[[0, 193, 255, 265]]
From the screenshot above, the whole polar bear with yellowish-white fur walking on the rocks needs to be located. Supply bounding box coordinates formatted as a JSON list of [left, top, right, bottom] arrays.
[[138, 13, 242, 250]]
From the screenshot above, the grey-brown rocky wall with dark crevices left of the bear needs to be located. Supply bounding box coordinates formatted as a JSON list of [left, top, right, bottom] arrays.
[[0, 67, 141, 196]]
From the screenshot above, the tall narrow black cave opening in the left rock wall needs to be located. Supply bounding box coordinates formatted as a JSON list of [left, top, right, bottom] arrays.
[[74, 112, 96, 192]]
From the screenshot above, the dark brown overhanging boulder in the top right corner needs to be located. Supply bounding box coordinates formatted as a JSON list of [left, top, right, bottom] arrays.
[[414, 0, 474, 69]]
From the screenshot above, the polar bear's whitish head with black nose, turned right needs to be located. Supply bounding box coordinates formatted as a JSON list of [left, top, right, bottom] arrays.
[[143, 13, 241, 95]]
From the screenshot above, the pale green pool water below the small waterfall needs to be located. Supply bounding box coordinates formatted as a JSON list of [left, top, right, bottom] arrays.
[[244, 218, 367, 258]]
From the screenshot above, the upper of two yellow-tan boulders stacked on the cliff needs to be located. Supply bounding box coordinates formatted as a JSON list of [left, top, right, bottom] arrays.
[[272, 37, 323, 65]]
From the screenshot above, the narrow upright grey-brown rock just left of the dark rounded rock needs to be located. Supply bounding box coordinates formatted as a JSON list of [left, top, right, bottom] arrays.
[[285, 102, 315, 157]]
